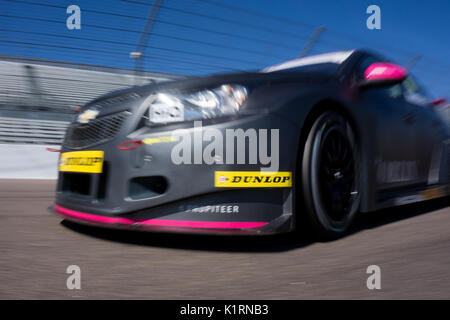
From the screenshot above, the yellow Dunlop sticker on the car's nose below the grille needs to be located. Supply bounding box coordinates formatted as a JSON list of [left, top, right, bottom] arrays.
[[59, 151, 103, 173]]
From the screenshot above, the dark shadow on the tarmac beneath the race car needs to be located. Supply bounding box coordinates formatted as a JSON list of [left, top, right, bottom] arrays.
[[61, 197, 450, 253]]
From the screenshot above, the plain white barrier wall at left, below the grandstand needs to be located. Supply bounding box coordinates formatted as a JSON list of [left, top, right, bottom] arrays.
[[0, 144, 59, 179]]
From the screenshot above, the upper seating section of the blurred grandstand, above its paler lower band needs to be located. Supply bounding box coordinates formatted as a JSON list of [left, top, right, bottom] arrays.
[[0, 55, 180, 119]]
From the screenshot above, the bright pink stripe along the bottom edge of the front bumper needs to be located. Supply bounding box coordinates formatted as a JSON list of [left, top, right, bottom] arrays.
[[55, 204, 267, 229]]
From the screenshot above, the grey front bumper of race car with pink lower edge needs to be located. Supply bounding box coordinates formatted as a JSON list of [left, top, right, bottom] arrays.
[[54, 115, 298, 234]]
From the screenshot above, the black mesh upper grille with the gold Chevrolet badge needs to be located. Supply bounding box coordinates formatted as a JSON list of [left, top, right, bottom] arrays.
[[64, 111, 130, 149]]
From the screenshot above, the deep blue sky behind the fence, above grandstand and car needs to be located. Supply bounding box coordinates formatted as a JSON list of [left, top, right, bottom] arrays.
[[0, 0, 450, 97]]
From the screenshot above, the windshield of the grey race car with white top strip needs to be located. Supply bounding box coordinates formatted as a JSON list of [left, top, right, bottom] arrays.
[[261, 51, 353, 73]]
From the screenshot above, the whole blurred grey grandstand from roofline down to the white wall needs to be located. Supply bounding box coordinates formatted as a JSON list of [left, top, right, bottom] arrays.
[[0, 56, 180, 145]]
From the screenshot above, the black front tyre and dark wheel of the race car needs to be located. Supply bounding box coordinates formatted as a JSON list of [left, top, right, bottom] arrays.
[[302, 111, 360, 239]]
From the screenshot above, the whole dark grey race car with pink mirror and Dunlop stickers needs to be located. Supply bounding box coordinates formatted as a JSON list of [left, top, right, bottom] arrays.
[[54, 50, 450, 237]]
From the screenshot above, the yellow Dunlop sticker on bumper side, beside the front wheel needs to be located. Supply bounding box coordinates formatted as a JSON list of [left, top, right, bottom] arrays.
[[214, 171, 292, 188]]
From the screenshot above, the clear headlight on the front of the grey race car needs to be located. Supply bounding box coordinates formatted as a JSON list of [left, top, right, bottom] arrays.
[[148, 85, 247, 124]]
